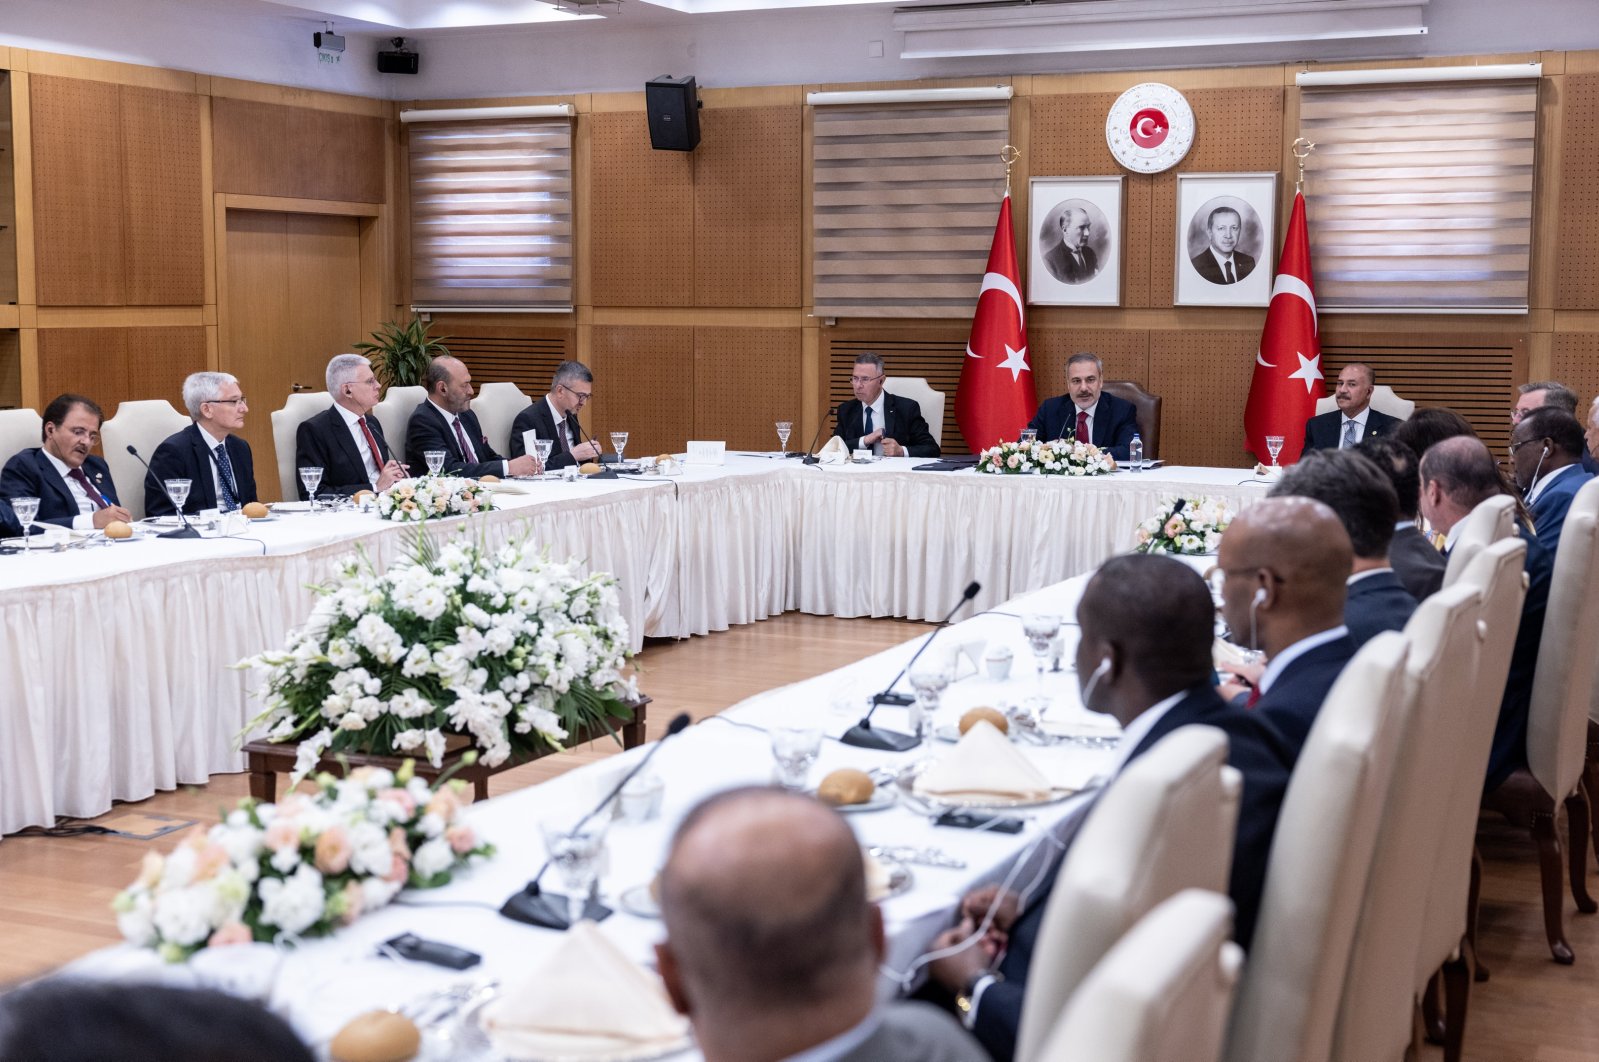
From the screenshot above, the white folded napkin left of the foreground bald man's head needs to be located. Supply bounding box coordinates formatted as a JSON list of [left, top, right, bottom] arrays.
[[483, 921, 689, 1059]]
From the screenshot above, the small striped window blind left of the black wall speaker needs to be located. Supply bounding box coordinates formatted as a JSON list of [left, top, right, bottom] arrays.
[[406, 118, 572, 310]]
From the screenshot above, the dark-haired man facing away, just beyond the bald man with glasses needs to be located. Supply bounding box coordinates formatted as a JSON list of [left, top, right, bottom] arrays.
[[1270, 449, 1417, 648]]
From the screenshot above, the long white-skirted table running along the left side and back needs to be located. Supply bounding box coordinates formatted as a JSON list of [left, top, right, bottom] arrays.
[[0, 454, 1263, 835]]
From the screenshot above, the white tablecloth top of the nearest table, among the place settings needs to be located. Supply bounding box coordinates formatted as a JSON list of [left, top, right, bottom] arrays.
[[70, 577, 1115, 1059]]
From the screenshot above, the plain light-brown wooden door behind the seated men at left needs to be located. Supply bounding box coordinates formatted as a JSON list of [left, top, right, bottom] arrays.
[[222, 210, 363, 501]]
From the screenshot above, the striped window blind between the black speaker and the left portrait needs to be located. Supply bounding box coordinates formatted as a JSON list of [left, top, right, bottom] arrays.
[[812, 101, 1011, 317]]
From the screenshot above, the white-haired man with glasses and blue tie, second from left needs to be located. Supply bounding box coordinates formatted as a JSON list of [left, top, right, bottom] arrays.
[[144, 373, 256, 517]]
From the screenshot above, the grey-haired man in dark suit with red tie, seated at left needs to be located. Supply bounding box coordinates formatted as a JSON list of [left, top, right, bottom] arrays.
[[294, 353, 406, 501]]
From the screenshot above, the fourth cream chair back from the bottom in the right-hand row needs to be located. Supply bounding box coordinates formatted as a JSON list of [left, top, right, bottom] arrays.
[[1332, 585, 1487, 1059]]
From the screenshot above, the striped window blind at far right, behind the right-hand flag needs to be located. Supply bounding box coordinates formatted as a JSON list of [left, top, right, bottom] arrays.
[[1300, 77, 1538, 312]]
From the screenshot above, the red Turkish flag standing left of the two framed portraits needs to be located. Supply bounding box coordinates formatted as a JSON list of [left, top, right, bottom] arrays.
[[955, 195, 1038, 451]]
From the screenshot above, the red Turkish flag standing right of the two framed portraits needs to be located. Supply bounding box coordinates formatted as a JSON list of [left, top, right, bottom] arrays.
[[1244, 194, 1326, 465]]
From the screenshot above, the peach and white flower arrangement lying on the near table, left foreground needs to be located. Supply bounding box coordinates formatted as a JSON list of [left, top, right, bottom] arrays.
[[112, 760, 494, 963]]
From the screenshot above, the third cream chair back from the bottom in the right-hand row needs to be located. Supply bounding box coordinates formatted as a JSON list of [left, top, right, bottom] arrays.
[[1225, 632, 1406, 1062]]
